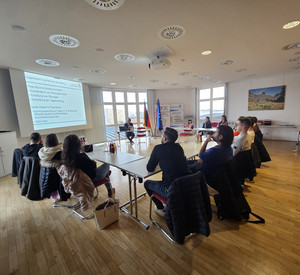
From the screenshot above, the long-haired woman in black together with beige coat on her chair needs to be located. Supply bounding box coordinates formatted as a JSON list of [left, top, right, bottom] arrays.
[[58, 135, 112, 210]]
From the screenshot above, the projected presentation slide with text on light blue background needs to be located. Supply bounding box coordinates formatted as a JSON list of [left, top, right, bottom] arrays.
[[24, 72, 86, 130]]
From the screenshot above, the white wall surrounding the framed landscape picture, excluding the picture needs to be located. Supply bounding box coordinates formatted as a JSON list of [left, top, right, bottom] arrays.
[[227, 72, 300, 141]]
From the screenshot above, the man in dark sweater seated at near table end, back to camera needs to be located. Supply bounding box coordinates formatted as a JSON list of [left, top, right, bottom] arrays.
[[144, 127, 188, 216]]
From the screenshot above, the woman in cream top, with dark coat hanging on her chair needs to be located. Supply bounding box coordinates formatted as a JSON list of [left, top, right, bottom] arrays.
[[38, 134, 66, 202]]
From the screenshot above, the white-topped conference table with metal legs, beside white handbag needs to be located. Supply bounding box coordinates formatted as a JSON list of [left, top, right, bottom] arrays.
[[87, 148, 161, 229]]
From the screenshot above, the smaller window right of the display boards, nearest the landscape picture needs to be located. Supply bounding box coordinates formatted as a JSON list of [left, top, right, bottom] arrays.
[[198, 86, 225, 125]]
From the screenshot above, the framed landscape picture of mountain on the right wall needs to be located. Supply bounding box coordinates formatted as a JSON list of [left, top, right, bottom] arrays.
[[248, 86, 285, 111]]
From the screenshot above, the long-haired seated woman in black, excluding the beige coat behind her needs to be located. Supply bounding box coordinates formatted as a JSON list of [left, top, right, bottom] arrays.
[[62, 135, 113, 197]]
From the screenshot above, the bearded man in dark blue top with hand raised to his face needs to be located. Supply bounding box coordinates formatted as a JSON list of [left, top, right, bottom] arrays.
[[188, 125, 233, 181]]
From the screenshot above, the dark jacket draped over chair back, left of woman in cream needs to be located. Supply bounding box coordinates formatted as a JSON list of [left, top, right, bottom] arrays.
[[18, 157, 41, 200]]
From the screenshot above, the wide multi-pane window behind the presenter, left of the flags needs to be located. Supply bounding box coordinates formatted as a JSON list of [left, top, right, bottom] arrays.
[[102, 90, 147, 140]]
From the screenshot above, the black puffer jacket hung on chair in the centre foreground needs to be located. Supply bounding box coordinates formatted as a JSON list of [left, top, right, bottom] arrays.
[[165, 172, 212, 243]]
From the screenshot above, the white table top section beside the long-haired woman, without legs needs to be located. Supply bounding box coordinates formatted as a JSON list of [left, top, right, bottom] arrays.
[[87, 149, 145, 168]]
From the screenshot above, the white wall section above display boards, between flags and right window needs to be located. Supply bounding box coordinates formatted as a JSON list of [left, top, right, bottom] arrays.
[[155, 89, 195, 117]]
